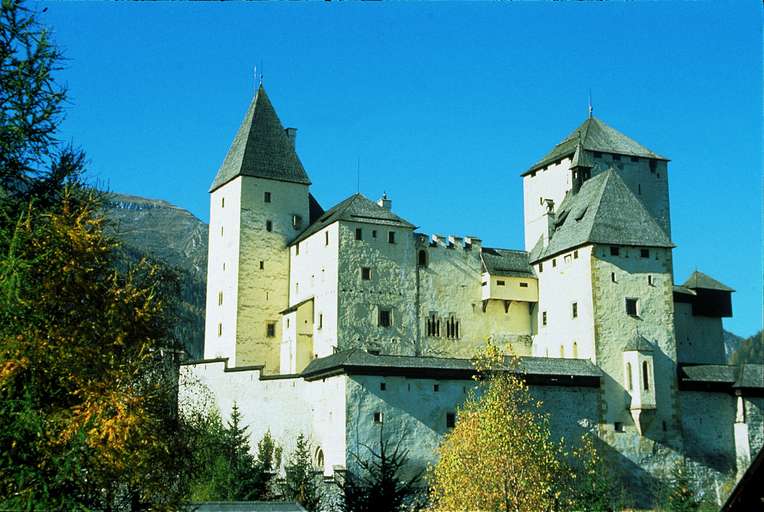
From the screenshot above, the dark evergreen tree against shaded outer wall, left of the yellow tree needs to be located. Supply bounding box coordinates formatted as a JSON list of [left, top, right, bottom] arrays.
[[337, 428, 423, 512]]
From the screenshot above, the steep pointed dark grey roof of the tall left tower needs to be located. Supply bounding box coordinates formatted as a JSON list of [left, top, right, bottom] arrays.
[[210, 85, 310, 192]]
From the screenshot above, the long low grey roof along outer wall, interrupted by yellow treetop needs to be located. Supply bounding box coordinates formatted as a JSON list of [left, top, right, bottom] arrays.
[[302, 348, 602, 385]]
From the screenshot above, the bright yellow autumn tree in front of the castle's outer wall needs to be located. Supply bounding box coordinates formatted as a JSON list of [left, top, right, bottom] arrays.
[[430, 345, 568, 511]]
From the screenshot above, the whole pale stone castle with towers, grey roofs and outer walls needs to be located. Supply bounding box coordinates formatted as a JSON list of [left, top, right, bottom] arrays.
[[181, 85, 764, 501]]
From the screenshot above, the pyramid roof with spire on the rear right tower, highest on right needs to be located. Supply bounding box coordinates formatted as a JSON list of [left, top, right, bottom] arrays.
[[522, 117, 667, 176]]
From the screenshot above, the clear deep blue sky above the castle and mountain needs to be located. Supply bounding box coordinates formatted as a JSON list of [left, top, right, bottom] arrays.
[[38, 1, 762, 336]]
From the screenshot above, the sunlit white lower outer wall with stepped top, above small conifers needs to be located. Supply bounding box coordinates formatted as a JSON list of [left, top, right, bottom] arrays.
[[179, 361, 346, 474]]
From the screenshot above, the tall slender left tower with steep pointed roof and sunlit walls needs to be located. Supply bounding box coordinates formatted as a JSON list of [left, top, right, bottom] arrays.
[[204, 85, 310, 373]]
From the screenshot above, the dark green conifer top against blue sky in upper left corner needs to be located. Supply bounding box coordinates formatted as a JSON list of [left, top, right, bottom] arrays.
[[0, 0, 85, 210]]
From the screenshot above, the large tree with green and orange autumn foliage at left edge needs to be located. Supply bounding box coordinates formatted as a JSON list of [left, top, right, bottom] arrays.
[[0, 189, 187, 510]]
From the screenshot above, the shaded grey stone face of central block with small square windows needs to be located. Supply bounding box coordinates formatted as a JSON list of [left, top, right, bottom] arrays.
[[335, 221, 417, 355]]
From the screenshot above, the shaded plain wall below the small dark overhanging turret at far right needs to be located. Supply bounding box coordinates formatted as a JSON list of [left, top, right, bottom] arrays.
[[674, 302, 726, 364]]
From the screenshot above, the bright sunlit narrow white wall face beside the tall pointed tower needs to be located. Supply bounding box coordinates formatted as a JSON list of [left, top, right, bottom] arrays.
[[289, 222, 339, 357]]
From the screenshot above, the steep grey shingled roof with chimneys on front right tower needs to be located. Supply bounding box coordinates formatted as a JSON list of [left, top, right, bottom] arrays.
[[531, 169, 674, 263]]
